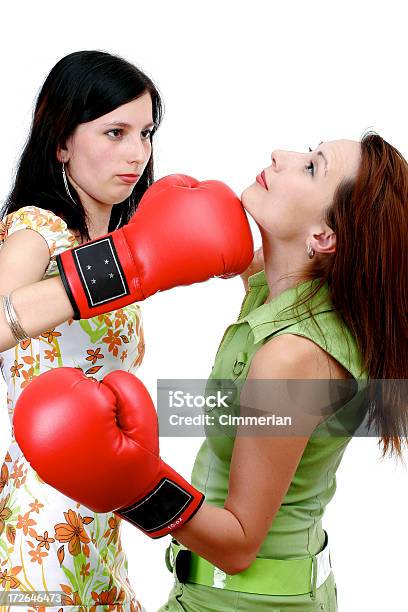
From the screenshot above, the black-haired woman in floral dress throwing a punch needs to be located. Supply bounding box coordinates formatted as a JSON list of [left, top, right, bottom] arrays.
[[0, 51, 162, 610]]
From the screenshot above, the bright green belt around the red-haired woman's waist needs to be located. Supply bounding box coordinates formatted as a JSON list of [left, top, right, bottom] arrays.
[[166, 540, 317, 595]]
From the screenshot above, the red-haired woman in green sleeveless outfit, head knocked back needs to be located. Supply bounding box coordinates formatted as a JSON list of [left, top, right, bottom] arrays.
[[155, 133, 408, 612]]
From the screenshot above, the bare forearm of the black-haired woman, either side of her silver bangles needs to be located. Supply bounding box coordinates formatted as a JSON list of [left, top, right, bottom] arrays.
[[0, 276, 74, 351]]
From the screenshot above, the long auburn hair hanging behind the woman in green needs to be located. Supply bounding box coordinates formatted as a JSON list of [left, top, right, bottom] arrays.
[[301, 131, 408, 459]]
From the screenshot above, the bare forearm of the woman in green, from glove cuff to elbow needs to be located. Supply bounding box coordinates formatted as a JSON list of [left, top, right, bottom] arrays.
[[173, 503, 252, 574]]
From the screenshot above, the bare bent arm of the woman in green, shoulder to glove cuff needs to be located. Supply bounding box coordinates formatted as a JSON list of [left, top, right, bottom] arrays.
[[173, 334, 347, 574]]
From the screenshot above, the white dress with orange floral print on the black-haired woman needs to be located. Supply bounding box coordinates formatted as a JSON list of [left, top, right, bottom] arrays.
[[0, 206, 144, 612]]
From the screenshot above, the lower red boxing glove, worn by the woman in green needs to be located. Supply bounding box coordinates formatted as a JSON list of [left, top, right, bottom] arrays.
[[13, 368, 204, 538]]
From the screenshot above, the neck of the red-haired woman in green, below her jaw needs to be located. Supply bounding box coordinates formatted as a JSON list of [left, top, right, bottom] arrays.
[[262, 236, 307, 303]]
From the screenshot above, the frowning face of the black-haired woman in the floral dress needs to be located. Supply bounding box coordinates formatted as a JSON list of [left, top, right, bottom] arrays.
[[57, 93, 153, 205]]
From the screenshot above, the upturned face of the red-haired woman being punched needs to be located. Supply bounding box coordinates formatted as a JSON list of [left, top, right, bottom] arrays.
[[241, 140, 360, 245]]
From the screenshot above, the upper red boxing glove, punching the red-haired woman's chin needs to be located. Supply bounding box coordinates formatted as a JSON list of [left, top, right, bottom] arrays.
[[56, 174, 253, 319]]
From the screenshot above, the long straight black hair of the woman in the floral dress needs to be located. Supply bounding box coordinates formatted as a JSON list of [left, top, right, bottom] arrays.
[[0, 51, 163, 240]]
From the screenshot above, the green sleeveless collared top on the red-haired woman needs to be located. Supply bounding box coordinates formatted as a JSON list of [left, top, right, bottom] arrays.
[[192, 271, 367, 559]]
